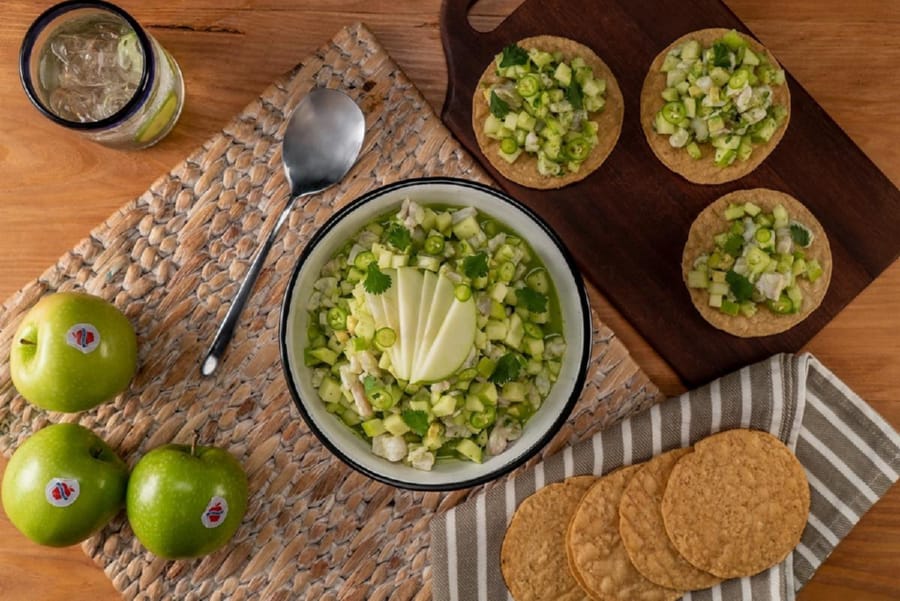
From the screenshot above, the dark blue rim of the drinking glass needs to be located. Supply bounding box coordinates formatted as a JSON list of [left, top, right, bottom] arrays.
[[19, 0, 156, 130]]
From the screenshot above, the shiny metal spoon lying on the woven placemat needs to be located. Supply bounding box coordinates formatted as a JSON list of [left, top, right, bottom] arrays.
[[200, 88, 366, 376]]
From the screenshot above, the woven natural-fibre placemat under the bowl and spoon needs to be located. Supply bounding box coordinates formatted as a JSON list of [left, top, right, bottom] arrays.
[[0, 24, 658, 600]]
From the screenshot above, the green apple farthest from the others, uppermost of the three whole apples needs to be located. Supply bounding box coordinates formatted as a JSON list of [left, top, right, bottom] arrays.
[[9, 292, 137, 412]]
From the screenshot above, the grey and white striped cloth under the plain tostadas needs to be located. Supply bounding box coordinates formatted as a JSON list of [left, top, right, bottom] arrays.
[[431, 354, 900, 601]]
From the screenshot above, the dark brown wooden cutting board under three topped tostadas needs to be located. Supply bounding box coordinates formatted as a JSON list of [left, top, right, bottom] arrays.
[[441, 0, 900, 386]]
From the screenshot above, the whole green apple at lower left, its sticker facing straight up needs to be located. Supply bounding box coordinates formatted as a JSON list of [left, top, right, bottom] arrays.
[[2, 424, 128, 547]]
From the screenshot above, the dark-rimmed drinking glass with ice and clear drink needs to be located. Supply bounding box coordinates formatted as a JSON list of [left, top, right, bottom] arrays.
[[19, 0, 184, 149]]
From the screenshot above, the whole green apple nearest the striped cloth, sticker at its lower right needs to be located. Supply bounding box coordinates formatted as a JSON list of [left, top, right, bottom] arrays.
[[126, 444, 248, 559]]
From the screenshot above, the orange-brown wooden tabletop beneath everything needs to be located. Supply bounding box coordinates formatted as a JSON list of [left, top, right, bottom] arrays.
[[0, 0, 900, 601]]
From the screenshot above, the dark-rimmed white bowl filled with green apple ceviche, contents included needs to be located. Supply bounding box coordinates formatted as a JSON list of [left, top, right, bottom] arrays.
[[280, 178, 591, 490]]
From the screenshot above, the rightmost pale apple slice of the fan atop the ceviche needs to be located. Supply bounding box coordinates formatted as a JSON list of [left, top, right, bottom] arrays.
[[413, 297, 476, 382]]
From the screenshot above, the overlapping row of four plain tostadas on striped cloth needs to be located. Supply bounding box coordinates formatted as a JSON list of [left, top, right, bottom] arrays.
[[500, 429, 810, 601]]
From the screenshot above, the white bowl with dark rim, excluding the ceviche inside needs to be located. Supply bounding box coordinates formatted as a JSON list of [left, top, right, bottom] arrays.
[[280, 178, 591, 490]]
